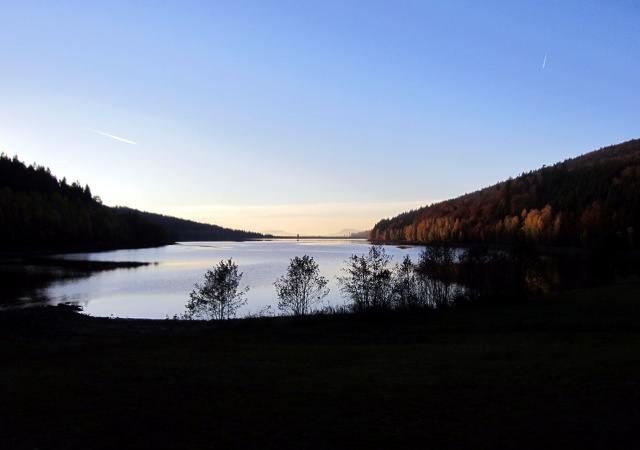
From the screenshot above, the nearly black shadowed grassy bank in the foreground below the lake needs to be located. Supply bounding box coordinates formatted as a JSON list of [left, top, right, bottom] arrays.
[[0, 282, 640, 450]]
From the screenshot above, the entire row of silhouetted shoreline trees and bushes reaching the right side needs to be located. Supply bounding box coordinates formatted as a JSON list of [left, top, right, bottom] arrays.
[[182, 244, 628, 320]]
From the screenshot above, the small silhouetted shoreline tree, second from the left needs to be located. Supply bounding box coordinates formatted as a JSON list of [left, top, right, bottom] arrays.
[[274, 255, 329, 316]]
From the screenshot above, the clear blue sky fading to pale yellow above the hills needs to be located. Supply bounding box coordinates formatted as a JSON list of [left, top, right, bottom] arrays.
[[0, 0, 640, 234]]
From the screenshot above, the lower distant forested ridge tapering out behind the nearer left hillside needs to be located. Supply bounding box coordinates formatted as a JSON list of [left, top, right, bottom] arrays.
[[115, 207, 270, 241]]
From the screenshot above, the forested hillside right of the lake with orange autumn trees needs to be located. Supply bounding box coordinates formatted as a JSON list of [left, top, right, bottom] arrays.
[[370, 140, 640, 248]]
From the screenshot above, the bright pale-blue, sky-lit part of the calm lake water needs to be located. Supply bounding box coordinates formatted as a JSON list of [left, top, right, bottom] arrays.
[[45, 239, 420, 319]]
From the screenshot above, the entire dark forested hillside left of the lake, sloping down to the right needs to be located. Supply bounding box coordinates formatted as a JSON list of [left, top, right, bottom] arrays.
[[0, 154, 260, 251]]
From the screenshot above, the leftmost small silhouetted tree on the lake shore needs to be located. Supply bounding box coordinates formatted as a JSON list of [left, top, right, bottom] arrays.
[[185, 259, 249, 320]]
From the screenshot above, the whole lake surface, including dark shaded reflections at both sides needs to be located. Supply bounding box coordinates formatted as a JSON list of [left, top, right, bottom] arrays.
[[0, 240, 637, 319]]
